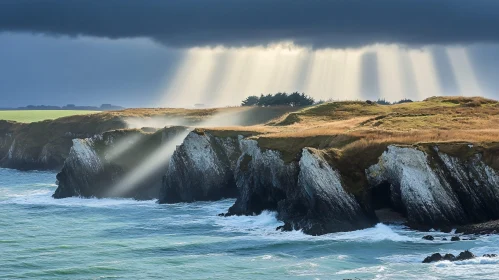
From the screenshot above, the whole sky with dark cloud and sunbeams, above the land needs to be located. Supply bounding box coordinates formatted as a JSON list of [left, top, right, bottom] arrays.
[[0, 0, 499, 107]]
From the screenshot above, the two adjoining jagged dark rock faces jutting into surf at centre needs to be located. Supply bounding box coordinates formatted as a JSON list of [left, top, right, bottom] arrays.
[[229, 143, 376, 235]]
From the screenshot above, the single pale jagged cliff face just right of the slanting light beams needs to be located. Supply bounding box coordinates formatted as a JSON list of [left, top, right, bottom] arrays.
[[159, 132, 241, 203]]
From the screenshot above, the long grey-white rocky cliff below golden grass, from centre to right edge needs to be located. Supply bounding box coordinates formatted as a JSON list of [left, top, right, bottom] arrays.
[[160, 132, 499, 235]]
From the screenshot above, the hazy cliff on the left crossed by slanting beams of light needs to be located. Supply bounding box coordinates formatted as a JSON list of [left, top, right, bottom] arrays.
[[53, 127, 186, 199]]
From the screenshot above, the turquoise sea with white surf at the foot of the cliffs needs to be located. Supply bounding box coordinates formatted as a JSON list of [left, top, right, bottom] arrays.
[[0, 169, 499, 279]]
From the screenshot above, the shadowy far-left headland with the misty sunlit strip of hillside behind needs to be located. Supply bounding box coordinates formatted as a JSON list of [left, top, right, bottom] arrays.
[[0, 107, 296, 170]]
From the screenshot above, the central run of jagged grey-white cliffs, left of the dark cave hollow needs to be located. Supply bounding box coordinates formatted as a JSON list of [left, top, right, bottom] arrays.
[[160, 135, 376, 235]]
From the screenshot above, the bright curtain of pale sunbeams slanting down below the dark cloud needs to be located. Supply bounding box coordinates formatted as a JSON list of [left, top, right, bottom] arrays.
[[160, 42, 468, 107]]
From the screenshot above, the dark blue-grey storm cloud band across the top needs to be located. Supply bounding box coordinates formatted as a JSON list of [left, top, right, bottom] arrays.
[[0, 0, 499, 47]]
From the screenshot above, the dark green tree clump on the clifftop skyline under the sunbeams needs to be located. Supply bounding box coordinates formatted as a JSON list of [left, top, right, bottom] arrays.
[[241, 92, 315, 107]]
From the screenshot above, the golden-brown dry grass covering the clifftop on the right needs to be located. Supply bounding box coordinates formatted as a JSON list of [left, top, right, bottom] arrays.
[[202, 97, 499, 163]]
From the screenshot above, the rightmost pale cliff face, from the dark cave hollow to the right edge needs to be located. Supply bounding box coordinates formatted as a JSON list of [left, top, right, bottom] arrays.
[[366, 144, 499, 228]]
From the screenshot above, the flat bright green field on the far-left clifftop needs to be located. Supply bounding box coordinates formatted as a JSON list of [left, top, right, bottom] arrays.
[[0, 110, 99, 123]]
